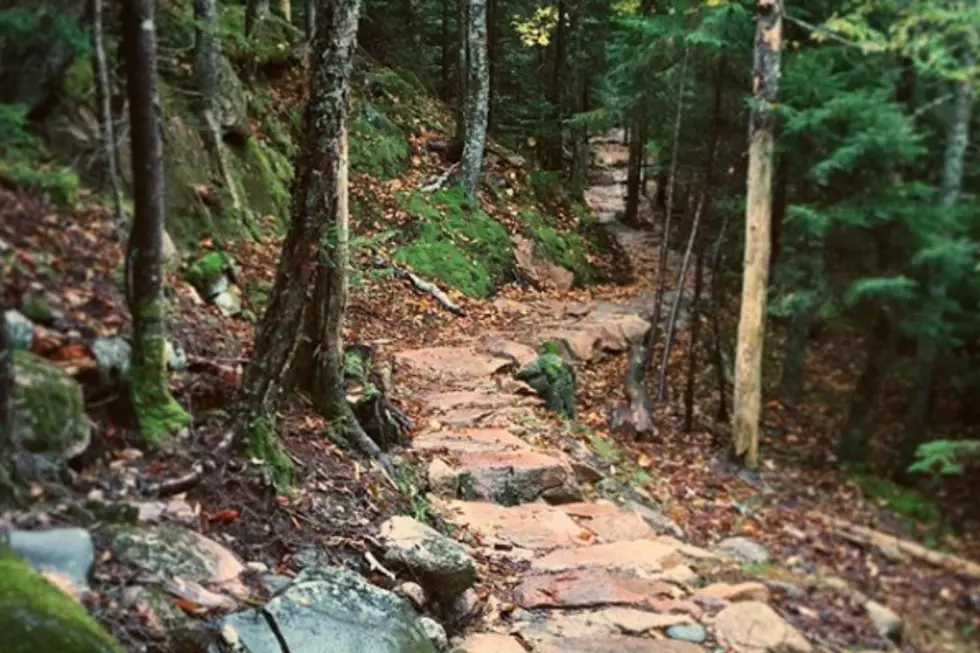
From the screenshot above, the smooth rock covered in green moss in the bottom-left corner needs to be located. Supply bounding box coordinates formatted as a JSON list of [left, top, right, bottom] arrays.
[[0, 546, 123, 653]]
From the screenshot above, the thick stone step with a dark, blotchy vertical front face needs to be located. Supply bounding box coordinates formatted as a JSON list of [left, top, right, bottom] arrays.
[[432, 450, 582, 505]]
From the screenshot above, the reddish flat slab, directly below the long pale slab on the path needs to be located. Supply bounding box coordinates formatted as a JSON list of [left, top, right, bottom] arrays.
[[514, 568, 679, 610]]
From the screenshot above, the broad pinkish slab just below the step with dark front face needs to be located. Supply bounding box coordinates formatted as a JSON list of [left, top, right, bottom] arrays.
[[433, 500, 591, 551]]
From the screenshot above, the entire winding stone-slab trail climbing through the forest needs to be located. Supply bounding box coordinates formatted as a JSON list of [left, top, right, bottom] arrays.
[[386, 134, 814, 653]]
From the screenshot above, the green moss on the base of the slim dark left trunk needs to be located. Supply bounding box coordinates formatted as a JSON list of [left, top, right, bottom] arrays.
[[126, 299, 191, 444]]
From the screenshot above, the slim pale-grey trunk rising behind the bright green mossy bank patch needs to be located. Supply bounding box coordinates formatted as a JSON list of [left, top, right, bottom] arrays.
[[460, 0, 490, 199]]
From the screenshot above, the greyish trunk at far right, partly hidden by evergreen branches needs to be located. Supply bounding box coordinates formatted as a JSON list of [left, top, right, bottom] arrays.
[[900, 63, 974, 470]]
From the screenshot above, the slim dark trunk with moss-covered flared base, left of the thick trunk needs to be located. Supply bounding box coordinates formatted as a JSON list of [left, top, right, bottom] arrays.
[[123, 0, 190, 442]]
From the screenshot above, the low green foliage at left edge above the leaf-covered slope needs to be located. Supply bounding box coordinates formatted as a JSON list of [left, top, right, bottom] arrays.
[[0, 103, 79, 207]]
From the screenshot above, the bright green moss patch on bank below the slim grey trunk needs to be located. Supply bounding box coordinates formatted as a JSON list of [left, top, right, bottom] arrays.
[[395, 188, 513, 297]]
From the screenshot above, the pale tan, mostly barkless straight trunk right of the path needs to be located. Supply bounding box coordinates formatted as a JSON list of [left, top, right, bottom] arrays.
[[732, 0, 782, 468]]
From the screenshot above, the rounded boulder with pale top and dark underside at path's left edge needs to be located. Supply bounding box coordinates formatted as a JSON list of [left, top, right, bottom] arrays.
[[380, 516, 476, 600]]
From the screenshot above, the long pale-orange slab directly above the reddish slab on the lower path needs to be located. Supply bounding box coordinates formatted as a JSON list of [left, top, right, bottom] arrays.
[[531, 540, 684, 573]]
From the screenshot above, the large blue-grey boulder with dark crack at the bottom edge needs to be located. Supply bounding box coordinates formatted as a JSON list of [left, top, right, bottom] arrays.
[[214, 567, 437, 653]]
